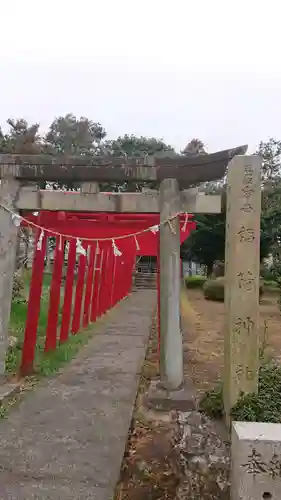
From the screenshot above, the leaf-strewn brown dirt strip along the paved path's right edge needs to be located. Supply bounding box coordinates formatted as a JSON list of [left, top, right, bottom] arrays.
[[115, 321, 179, 500]]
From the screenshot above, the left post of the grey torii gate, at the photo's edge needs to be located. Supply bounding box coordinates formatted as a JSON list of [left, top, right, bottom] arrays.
[[0, 178, 19, 381]]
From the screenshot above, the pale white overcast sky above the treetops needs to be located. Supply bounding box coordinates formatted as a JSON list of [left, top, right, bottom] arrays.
[[0, 0, 281, 152]]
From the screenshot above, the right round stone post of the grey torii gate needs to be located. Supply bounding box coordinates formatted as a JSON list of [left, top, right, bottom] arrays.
[[160, 179, 183, 390]]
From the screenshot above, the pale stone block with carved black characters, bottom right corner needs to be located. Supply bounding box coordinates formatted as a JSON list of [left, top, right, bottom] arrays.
[[231, 422, 281, 500]]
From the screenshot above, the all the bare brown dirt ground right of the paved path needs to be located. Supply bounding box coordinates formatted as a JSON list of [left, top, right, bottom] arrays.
[[115, 289, 281, 500]]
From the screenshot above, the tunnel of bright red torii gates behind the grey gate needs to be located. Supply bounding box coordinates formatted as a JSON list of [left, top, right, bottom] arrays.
[[21, 211, 195, 375]]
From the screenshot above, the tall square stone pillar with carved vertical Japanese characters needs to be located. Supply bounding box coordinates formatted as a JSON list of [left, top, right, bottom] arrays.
[[223, 156, 261, 421]]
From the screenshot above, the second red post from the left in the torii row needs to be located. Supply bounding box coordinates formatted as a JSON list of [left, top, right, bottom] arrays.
[[45, 236, 64, 351]]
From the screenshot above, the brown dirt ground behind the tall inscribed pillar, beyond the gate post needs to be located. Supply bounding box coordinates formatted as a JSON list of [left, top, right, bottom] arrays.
[[181, 289, 281, 392]]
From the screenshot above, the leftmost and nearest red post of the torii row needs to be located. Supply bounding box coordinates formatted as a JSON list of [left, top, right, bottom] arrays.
[[20, 230, 47, 376]]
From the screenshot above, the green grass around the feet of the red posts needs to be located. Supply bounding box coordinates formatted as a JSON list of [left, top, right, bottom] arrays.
[[6, 271, 92, 376]]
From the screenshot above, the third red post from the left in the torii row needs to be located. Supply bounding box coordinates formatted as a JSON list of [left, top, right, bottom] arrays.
[[60, 240, 76, 342]]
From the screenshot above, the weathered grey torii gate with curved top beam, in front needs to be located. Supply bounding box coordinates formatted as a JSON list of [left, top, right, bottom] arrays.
[[0, 146, 260, 410]]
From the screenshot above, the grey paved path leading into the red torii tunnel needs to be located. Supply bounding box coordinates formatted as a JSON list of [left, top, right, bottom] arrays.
[[0, 290, 156, 500]]
